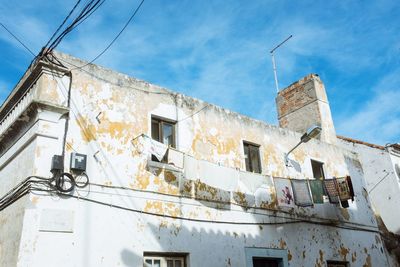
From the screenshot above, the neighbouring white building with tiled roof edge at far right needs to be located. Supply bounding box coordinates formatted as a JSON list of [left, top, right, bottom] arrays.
[[338, 136, 400, 261]]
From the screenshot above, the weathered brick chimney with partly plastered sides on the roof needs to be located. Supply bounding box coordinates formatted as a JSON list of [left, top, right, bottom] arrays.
[[276, 74, 336, 144]]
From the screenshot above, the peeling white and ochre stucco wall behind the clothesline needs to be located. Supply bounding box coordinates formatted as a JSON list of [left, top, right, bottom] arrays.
[[0, 52, 395, 267]]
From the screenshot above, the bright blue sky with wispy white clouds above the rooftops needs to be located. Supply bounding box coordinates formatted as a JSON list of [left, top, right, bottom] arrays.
[[0, 0, 400, 145]]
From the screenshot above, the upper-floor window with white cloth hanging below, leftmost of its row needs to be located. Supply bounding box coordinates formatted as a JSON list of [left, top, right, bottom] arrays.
[[151, 117, 176, 148]]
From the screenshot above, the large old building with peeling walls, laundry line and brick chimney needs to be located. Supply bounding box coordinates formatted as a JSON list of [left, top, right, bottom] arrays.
[[0, 53, 397, 267]]
